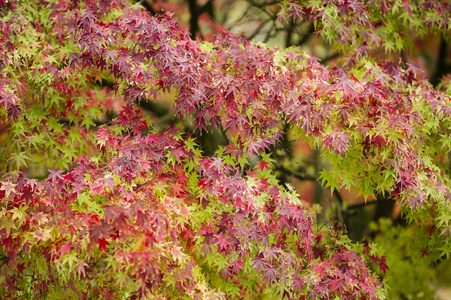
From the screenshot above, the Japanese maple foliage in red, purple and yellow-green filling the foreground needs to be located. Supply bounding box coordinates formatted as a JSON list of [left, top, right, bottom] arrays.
[[0, 0, 451, 299]]
